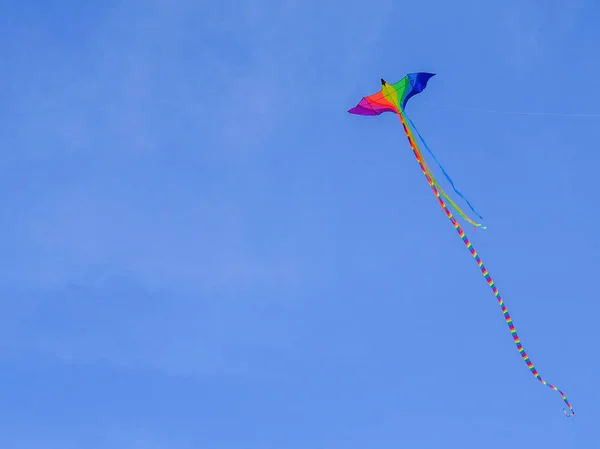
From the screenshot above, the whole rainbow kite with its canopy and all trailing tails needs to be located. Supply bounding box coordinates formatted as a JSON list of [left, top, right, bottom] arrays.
[[348, 72, 575, 416]]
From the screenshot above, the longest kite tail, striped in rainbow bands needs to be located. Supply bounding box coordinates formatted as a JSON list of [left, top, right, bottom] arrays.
[[398, 112, 575, 416]]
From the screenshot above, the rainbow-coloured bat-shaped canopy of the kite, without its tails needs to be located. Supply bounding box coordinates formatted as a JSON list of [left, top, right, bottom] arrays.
[[348, 72, 435, 115]]
